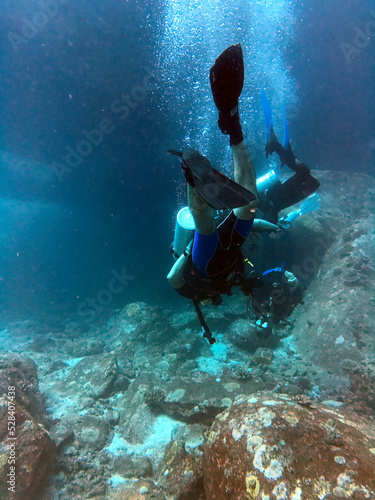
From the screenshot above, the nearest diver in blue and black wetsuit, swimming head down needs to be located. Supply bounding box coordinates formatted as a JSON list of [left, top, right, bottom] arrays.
[[168, 45, 258, 343]]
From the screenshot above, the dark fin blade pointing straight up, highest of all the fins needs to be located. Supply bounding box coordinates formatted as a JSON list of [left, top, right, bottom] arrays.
[[210, 43, 245, 116]]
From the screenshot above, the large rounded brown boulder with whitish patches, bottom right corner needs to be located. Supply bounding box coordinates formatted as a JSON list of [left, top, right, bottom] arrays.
[[203, 393, 375, 500]]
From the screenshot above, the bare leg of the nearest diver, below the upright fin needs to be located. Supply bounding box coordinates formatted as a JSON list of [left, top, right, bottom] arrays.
[[232, 141, 258, 220]]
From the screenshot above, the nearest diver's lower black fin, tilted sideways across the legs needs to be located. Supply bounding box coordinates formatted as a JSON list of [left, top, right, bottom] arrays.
[[182, 149, 255, 210]]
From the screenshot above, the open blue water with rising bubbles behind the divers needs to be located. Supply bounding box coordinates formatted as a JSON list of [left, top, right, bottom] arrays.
[[0, 0, 375, 317]]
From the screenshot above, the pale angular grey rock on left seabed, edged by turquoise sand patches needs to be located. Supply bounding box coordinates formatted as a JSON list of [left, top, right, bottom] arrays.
[[54, 354, 117, 400]]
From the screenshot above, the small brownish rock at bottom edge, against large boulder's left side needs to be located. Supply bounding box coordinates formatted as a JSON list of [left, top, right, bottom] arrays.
[[156, 441, 205, 500]]
